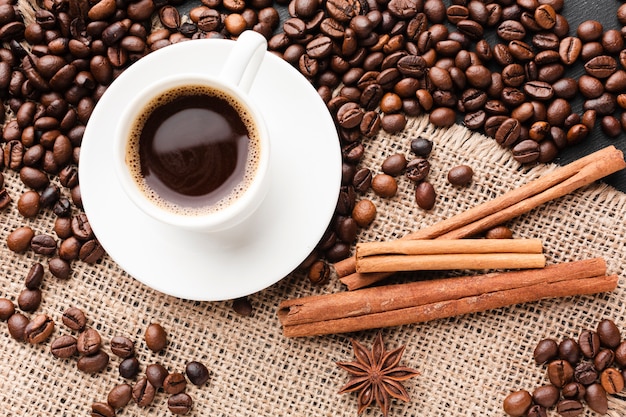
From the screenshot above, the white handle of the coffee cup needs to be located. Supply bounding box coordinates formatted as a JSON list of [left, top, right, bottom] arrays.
[[220, 30, 267, 92]]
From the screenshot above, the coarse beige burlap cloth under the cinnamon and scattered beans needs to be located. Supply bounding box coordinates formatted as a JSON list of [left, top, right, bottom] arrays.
[[0, 105, 626, 417]]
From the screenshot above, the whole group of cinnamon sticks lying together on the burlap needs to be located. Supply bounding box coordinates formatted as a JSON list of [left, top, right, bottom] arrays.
[[278, 146, 626, 337]]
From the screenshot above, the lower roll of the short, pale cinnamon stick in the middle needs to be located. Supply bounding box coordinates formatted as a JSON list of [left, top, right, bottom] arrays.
[[356, 253, 546, 273]]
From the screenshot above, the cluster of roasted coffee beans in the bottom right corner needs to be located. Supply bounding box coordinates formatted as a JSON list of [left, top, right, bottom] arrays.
[[503, 319, 626, 417]]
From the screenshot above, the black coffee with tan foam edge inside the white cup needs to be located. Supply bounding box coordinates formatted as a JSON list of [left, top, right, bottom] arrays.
[[127, 85, 260, 214]]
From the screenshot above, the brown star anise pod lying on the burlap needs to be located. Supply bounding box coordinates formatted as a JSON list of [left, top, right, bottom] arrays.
[[337, 332, 419, 417]]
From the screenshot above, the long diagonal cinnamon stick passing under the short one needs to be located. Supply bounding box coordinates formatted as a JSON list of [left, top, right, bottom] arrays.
[[333, 146, 626, 290]]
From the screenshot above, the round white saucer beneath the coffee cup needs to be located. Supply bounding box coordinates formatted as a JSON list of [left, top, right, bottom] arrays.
[[79, 39, 341, 301]]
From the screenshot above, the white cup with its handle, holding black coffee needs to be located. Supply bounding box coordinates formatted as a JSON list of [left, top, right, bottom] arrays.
[[113, 31, 271, 232]]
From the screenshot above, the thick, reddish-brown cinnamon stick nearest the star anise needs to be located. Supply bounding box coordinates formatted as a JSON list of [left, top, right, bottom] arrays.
[[278, 258, 617, 337]]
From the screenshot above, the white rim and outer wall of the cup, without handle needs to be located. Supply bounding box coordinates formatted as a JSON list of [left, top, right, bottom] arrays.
[[113, 73, 271, 232]]
